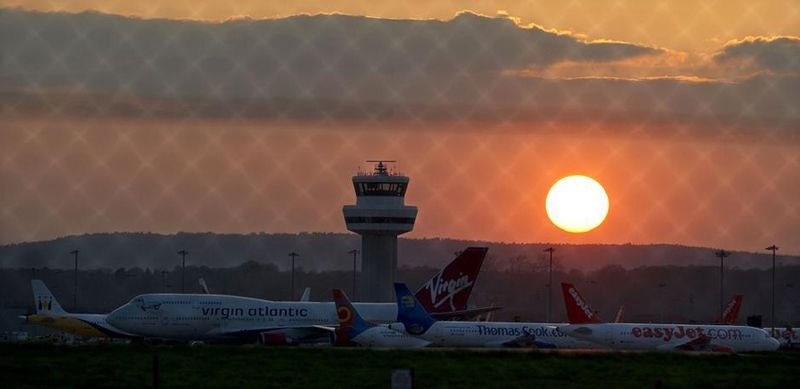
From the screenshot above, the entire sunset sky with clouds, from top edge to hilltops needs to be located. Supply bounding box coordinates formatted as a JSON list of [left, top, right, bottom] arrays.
[[0, 1, 800, 254]]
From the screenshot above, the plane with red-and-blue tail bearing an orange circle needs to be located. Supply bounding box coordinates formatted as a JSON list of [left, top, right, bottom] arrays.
[[326, 289, 431, 348]]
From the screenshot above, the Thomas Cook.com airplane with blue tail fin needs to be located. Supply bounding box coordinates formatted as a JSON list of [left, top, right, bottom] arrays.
[[389, 283, 599, 349]]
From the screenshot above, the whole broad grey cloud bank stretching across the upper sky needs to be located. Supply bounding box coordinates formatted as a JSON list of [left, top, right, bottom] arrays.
[[0, 9, 800, 128]]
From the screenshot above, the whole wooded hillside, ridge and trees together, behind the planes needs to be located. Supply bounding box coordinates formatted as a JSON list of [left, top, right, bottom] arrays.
[[0, 233, 800, 331]]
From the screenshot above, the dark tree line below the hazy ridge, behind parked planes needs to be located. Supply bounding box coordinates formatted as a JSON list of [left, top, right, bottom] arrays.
[[0, 256, 800, 326]]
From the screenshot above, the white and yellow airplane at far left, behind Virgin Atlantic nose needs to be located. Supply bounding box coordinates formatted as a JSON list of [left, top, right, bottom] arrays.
[[20, 280, 136, 338]]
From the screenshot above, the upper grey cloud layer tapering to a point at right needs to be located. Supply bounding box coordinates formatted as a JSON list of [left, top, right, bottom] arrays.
[[2, 10, 657, 95]]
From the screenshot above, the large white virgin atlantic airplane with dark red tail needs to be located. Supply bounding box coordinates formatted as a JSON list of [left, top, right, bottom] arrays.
[[107, 247, 497, 344]]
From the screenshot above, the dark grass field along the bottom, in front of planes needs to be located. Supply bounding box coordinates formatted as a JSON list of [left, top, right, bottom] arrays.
[[0, 344, 800, 388]]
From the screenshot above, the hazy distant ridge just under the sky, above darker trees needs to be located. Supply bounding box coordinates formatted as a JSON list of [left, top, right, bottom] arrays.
[[0, 232, 800, 271]]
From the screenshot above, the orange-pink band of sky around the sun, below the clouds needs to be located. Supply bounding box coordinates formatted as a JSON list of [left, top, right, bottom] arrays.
[[0, 116, 800, 254]]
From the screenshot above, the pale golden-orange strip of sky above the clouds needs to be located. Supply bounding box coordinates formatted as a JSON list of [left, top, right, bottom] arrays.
[[6, 0, 800, 52]]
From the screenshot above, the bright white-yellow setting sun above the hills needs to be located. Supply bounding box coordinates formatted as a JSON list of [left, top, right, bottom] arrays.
[[545, 176, 608, 233]]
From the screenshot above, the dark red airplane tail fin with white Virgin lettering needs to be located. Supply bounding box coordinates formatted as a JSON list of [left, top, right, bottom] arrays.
[[415, 247, 489, 313]]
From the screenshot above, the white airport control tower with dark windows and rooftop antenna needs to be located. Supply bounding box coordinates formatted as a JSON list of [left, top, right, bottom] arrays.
[[342, 161, 417, 302]]
